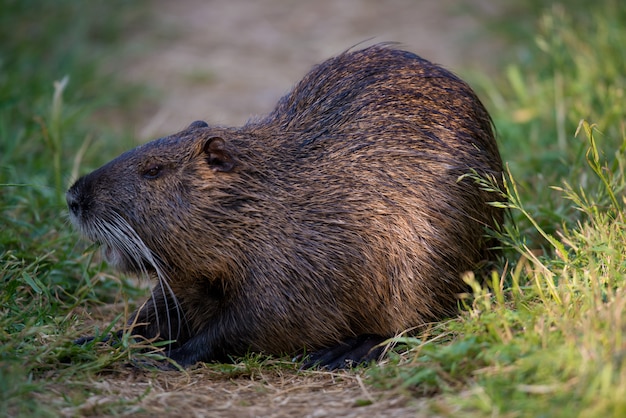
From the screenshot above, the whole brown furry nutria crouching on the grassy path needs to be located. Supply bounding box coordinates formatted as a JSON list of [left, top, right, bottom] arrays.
[[67, 45, 503, 368]]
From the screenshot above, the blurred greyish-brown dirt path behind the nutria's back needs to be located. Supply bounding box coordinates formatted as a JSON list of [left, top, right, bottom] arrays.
[[112, 0, 502, 137]]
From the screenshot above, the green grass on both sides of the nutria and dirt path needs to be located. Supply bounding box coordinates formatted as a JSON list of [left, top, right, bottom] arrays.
[[0, 0, 626, 417]]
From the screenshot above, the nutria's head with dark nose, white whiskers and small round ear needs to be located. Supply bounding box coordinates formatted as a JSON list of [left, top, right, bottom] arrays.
[[66, 121, 236, 277]]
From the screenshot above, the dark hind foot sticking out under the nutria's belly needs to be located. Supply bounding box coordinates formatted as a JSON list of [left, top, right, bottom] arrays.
[[302, 335, 387, 370]]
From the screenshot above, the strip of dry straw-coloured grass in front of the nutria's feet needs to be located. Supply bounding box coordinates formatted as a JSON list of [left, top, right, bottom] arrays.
[[37, 361, 427, 417]]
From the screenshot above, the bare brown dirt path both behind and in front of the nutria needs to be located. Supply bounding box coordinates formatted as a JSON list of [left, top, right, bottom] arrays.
[[95, 0, 499, 417]]
